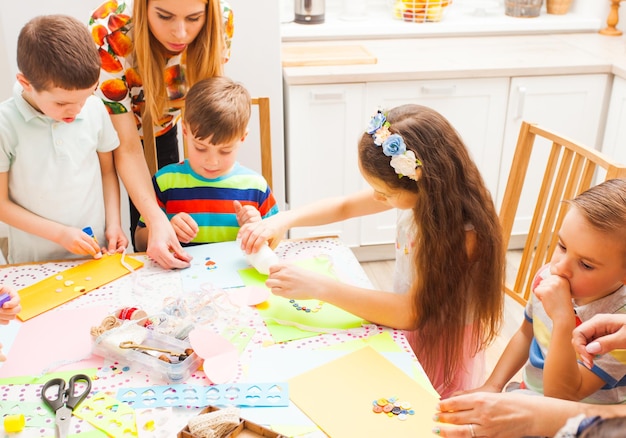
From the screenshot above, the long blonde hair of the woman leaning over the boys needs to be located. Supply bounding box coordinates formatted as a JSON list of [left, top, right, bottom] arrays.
[[133, 0, 224, 123]]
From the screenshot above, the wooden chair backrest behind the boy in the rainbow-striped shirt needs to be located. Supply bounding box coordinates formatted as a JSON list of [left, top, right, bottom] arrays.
[[144, 97, 273, 188]]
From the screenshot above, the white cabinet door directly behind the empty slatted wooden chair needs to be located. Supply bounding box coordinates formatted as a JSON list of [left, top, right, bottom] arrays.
[[494, 74, 610, 243]]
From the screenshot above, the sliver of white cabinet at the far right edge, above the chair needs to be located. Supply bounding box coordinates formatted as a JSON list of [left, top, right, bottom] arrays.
[[602, 77, 626, 163]]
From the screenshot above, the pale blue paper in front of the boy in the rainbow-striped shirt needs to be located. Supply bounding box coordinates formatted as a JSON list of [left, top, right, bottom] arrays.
[[180, 241, 250, 291]]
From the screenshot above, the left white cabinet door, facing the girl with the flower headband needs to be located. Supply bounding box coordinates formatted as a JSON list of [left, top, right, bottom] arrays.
[[284, 84, 366, 246]]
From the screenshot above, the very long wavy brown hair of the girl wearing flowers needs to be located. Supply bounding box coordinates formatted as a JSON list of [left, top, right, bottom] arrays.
[[359, 105, 505, 385]]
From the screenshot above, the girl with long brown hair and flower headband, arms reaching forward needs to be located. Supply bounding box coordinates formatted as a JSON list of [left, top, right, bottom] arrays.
[[240, 105, 505, 397]]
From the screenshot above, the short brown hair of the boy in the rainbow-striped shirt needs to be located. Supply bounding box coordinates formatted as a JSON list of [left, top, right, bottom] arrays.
[[185, 76, 251, 144]]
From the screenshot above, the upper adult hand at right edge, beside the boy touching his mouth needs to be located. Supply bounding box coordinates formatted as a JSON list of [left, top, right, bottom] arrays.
[[572, 314, 626, 368]]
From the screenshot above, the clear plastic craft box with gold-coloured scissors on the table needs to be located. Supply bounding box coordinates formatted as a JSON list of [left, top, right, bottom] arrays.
[[93, 323, 202, 383]]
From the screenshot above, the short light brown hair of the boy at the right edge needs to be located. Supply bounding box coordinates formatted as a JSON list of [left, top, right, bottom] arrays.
[[566, 178, 626, 263]]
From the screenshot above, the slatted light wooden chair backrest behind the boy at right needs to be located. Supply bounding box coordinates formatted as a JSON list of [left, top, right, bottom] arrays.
[[500, 122, 626, 305]]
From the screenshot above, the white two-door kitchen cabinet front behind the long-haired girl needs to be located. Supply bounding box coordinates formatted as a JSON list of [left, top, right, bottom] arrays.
[[285, 78, 509, 246]]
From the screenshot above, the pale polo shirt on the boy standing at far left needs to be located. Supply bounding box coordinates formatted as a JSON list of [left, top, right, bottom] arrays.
[[0, 82, 119, 263]]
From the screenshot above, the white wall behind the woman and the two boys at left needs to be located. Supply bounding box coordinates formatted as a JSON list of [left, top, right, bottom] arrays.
[[0, 0, 285, 240]]
